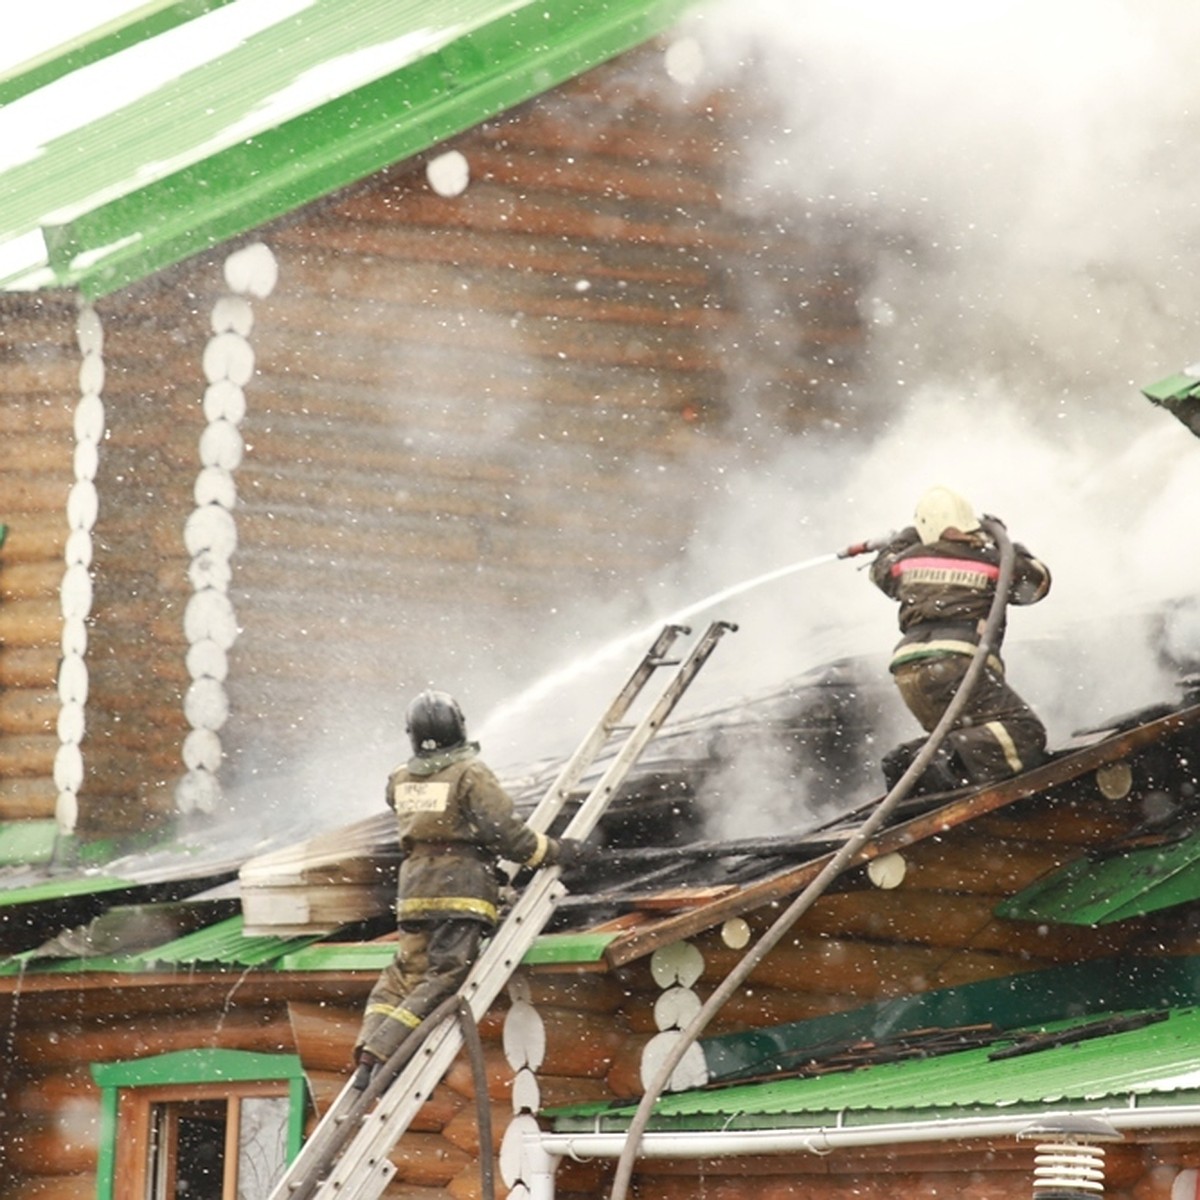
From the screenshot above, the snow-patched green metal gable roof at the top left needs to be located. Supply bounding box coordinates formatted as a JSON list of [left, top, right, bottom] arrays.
[[0, 0, 692, 298]]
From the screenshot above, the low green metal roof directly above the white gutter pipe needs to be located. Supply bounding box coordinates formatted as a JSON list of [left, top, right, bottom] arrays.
[[548, 1008, 1200, 1132]]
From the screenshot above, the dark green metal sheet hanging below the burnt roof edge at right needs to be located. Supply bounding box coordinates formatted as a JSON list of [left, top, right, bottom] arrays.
[[996, 830, 1200, 925]]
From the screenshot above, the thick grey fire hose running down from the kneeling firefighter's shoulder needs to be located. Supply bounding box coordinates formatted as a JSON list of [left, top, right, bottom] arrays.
[[610, 517, 1014, 1200]]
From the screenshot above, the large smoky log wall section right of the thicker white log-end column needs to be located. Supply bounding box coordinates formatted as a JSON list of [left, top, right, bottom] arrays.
[[206, 42, 858, 772]]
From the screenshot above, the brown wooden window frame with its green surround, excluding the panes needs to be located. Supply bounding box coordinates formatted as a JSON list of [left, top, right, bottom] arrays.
[[91, 1050, 307, 1200]]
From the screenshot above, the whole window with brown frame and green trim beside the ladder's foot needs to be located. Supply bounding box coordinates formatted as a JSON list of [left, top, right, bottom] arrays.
[[91, 1050, 305, 1200]]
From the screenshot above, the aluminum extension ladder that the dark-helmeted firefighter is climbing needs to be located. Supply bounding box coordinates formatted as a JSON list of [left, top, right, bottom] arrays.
[[269, 622, 737, 1200]]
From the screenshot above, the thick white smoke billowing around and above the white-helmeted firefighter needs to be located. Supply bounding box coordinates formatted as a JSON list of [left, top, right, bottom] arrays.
[[482, 0, 1200, 834]]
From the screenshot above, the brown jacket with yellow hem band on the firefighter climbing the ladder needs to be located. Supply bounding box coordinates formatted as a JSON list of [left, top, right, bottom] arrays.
[[386, 742, 558, 925]]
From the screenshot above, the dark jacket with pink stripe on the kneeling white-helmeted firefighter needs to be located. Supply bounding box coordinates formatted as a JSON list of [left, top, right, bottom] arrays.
[[871, 527, 1050, 671]]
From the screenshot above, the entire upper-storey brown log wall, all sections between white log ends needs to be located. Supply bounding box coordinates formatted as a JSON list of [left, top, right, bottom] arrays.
[[0, 39, 862, 835]]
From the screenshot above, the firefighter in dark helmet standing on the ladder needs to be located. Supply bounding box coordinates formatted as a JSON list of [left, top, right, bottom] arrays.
[[354, 691, 584, 1087]]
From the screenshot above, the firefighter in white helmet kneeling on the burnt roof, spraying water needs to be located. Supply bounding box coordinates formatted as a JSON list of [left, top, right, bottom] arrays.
[[871, 487, 1050, 791]]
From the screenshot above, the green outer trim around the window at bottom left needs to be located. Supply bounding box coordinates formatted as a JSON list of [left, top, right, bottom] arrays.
[[91, 1049, 306, 1200]]
